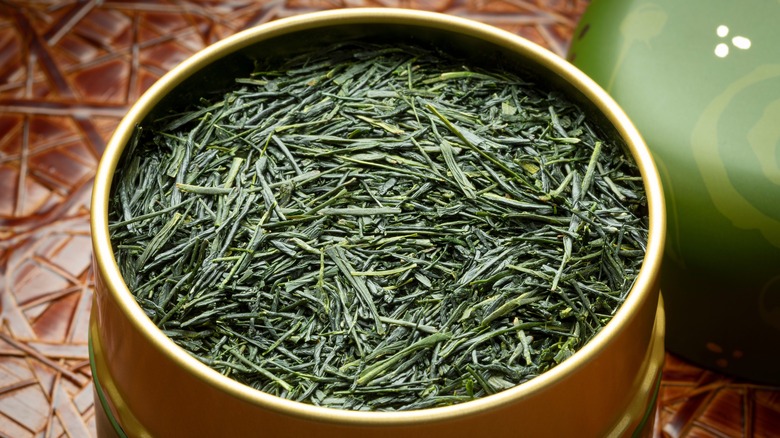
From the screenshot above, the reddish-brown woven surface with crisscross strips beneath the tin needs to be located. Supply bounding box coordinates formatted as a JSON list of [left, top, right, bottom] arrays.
[[0, 0, 780, 438]]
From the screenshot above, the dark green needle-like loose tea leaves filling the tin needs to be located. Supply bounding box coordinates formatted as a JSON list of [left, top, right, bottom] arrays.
[[109, 43, 647, 410]]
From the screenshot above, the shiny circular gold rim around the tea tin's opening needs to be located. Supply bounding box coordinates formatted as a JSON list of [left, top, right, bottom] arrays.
[[91, 8, 666, 426]]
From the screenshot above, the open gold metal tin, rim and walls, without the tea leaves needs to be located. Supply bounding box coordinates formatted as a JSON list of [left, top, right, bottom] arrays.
[[91, 9, 665, 437]]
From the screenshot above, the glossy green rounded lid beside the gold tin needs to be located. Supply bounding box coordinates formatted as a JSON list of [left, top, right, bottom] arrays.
[[569, 0, 780, 383]]
